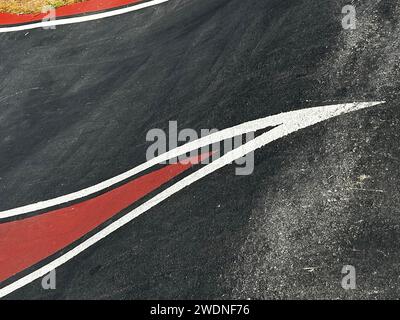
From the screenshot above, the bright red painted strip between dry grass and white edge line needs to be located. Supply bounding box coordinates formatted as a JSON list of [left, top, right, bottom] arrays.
[[0, 0, 144, 25]]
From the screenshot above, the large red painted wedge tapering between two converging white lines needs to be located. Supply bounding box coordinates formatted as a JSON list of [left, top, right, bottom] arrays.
[[0, 155, 209, 281]]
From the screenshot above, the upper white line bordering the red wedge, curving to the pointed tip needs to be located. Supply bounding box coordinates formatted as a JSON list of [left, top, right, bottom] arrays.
[[0, 102, 382, 220]]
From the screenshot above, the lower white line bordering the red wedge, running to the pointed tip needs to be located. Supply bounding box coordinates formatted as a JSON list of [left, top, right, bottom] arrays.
[[0, 102, 383, 297]]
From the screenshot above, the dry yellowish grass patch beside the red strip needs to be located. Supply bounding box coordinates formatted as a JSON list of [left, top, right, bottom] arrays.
[[0, 0, 85, 14]]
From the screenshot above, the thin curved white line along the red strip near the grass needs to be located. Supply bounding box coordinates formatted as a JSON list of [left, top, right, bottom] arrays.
[[0, 0, 170, 33]]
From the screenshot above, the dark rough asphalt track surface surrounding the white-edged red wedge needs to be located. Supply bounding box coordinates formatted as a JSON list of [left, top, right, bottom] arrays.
[[0, 0, 400, 299]]
